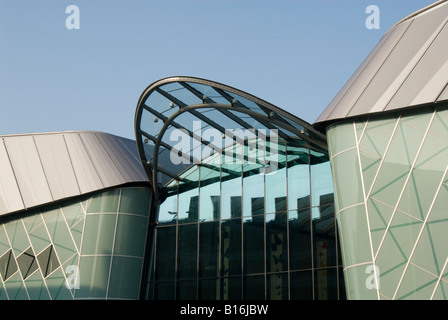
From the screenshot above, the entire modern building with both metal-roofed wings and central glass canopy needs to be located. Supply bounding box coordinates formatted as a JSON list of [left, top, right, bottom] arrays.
[[0, 0, 448, 300]]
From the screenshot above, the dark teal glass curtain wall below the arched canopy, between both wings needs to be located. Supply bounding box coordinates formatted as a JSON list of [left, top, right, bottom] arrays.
[[146, 140, 345, 300]]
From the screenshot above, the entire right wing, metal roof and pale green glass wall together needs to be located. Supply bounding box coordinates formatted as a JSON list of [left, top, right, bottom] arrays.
[[315, 1, 448, 299]]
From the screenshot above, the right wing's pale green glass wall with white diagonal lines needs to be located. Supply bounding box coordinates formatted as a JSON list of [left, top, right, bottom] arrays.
[[327, 106, 448, 300]]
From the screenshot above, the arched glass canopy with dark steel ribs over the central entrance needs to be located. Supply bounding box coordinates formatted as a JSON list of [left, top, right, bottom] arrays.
[[135, 77, 326, 197]]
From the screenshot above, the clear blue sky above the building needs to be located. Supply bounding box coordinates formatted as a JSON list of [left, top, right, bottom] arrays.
[[0, 0, 435, 139]]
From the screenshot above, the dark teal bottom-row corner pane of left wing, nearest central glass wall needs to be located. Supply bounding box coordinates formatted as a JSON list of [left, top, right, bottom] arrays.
[[108, 256, 143, 300]]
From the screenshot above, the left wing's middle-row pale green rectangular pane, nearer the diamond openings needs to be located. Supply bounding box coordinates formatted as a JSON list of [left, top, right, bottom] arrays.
[[82, 214, 117, 254]]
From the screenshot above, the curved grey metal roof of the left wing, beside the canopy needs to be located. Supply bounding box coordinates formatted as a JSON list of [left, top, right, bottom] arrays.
[[0, 131, 148, 215]]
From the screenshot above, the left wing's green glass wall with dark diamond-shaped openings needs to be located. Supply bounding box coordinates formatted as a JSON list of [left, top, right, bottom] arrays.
[[0, 187, 152, 300]]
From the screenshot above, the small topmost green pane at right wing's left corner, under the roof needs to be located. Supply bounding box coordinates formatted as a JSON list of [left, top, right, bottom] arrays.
[[327, 121, 356, 155]]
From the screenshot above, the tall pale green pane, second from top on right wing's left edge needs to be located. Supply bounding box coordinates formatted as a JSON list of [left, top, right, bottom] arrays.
[[332, 150, 364, 210]]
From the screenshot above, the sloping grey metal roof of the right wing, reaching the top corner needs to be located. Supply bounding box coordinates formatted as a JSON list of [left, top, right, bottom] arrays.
[[316, 0, 448, 126]]
